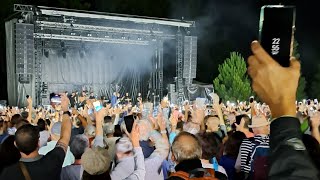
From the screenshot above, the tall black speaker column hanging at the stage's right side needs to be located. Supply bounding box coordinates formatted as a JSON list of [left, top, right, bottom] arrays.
[[183, 36, 198, 79]]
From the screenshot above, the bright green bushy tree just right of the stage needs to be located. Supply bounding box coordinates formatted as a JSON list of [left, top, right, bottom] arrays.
[[213, 52, 253, 101]]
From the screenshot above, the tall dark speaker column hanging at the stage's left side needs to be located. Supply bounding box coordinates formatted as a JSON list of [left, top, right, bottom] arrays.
[[15, 23, 34, 83]]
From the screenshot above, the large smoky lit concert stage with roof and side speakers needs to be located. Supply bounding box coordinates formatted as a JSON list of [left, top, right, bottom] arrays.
[[6, 4, 197, 106]]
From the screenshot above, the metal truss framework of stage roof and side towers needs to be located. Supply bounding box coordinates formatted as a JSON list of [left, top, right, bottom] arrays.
[[8, 4, 195, 105]]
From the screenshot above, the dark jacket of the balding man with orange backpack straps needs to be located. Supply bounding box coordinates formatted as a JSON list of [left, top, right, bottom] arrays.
[[168, 159, 227, 180]]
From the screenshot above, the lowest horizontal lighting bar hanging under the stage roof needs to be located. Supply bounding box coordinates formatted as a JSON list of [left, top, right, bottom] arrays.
[[34, 33, 149, 45]]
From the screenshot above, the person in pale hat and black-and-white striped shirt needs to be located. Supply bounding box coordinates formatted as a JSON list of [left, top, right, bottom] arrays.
[[235, 115, 270, 174]]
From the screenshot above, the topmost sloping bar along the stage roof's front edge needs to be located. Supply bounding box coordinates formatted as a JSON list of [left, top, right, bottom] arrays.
[[39, 6, 194, 28]]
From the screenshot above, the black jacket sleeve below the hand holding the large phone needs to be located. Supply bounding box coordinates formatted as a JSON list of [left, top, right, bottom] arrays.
[[268, 117, 319, 180]]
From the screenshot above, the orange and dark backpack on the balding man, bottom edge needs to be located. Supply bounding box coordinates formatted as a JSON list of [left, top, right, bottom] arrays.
[[170, 168, 218, 180]]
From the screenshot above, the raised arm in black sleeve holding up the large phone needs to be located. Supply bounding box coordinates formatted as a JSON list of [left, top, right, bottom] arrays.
[[248, 42, 318, 180]]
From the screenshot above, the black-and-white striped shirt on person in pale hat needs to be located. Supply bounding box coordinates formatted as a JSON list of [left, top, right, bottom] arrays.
[[238, 135, 269, 173]]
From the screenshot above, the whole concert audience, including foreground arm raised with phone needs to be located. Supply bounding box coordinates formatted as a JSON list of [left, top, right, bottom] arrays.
[[0, 42, 320, 180]]
